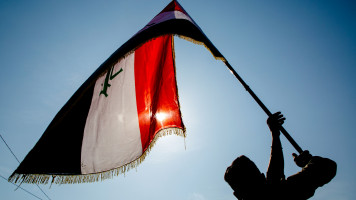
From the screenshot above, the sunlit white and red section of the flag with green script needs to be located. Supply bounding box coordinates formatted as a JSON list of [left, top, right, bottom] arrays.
[[81, 35, 184, 174]]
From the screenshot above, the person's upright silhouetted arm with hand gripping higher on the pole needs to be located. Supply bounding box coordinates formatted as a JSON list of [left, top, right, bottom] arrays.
[[267, 112, 285, 184]]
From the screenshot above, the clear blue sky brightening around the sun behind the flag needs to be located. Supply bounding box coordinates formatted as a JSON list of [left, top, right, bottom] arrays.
[[0, 0, 356, 200]]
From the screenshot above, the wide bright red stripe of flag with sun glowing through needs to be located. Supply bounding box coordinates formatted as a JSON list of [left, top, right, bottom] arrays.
[[135, 35, 184, 151]]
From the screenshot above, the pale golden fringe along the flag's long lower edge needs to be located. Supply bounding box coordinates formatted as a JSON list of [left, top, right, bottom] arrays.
[[8, 128, 186, 184]]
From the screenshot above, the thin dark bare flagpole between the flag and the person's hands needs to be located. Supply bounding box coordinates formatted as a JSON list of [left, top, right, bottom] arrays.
[[224, 60, 303, 153]]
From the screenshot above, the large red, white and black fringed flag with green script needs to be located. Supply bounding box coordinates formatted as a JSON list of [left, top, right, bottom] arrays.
[[9, 1, 225, 184]]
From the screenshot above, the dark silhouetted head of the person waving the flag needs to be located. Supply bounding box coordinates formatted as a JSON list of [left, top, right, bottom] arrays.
[[224, 156, 266, 200]]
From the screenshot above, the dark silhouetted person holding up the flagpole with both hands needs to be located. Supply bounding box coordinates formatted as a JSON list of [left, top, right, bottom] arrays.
[[224, 112, 336, 200]]
